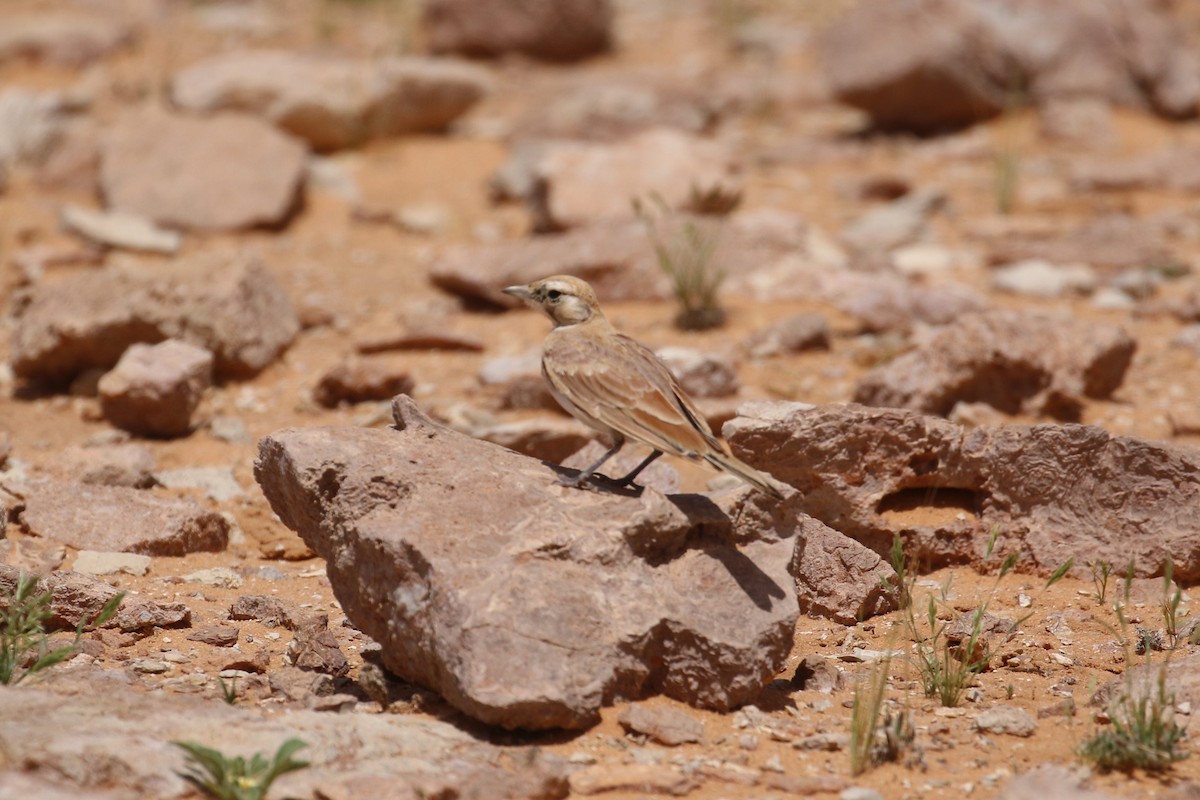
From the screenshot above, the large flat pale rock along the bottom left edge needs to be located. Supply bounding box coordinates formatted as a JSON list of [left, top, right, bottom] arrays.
[[0, 670, 566, 800]]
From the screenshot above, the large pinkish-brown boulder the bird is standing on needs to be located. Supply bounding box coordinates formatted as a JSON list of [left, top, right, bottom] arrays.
[[254, 396, 797, 729]]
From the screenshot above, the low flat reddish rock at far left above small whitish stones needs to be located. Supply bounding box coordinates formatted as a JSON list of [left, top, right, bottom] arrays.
[[20, 481, 229, 555]]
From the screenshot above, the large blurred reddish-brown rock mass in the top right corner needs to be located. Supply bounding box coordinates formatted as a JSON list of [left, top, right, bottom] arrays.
[[821, 0, 1200, 133]]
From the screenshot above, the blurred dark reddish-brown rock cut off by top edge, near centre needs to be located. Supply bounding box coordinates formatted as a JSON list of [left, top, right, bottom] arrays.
[[422, 0, 613, 61]]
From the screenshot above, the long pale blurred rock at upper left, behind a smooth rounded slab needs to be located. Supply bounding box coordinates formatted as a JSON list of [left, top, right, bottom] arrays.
[[170, 50, 490, 151]]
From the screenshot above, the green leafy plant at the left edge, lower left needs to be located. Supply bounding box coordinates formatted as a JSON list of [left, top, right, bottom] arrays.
[[0, 571, 125, 685]]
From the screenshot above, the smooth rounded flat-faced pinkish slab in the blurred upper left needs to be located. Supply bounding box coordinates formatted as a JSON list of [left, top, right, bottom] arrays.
[[101, 109, 306, 230]]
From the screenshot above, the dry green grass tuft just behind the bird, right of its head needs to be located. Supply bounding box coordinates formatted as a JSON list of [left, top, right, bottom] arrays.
[[634, 196, 726, 331]]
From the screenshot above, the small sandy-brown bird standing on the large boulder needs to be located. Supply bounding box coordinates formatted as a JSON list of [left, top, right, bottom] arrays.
[[504, 275, 784, 498]]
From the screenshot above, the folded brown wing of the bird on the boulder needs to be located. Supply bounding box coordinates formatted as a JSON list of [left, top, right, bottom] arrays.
[[542, 335, 724, 456]]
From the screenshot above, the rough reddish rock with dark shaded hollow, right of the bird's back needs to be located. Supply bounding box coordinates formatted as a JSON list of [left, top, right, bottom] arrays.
[[854, 309, 1135, 420]]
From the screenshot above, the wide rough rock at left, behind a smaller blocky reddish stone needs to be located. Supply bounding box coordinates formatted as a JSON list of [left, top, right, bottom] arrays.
[[11, 253, 300, 383]]
